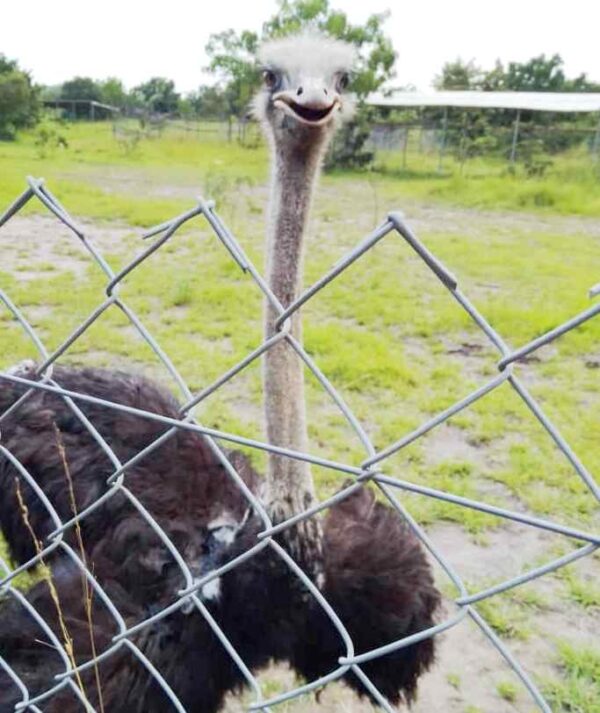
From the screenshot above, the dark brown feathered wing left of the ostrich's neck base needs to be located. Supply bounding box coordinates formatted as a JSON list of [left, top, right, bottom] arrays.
[[0, 366, 258, 584]]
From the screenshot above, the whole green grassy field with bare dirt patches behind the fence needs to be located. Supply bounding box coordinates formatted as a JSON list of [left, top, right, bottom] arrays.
[[0, 123, 600, 713]]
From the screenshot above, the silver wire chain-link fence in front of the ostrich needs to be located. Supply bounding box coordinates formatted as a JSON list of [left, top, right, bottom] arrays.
[[0, 178, 600, 712]]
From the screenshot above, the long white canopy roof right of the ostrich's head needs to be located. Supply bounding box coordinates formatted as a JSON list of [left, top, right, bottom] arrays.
[[367, 91, 600, 112]]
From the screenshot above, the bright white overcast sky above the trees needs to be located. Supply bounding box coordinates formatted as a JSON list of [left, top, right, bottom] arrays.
[[0, 0, 600, 92]]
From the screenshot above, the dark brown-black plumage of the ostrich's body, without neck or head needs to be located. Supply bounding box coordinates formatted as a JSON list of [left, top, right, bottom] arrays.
[[0, 367, 439, 713]]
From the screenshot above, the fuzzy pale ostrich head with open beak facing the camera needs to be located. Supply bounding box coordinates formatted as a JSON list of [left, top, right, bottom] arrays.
[[254, 34, 355, 153]]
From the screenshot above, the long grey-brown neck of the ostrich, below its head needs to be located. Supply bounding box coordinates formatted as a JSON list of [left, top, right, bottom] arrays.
[[264, 132, 327, 528]]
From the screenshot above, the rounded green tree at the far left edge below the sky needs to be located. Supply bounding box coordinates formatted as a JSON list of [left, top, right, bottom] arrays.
[[0, 54, 40, 139]]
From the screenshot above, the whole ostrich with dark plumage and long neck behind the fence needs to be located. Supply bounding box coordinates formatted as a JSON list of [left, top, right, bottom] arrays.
[[0, 35, 439, 713]]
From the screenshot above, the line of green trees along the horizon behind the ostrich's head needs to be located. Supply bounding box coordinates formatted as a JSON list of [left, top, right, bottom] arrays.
[[0, 0, 600, 164]]
